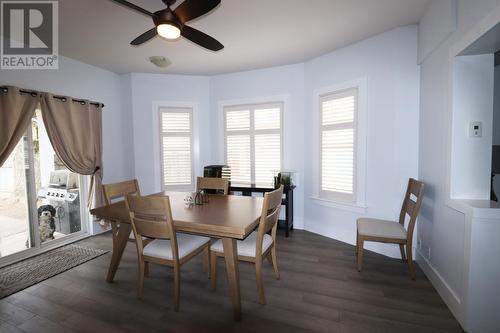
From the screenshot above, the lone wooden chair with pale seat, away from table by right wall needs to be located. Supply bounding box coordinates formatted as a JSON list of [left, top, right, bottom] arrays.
[[356, 178, 424, 280]]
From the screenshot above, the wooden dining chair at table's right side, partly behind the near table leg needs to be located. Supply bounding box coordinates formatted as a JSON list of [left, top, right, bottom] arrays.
[[210, 185, 283, 304]]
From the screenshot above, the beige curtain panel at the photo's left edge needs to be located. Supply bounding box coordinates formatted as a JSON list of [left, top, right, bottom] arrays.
[[0, 87, 40, 167]]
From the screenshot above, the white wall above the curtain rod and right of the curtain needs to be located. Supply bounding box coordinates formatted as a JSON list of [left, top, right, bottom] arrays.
[[0, 56, 134, 182]]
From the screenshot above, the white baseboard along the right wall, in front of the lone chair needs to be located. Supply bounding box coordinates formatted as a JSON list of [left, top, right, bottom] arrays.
[[416, 250, 465, 328]]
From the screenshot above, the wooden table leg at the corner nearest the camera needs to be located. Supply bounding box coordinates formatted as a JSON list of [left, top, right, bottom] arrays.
[[222, 238, 241, 321]]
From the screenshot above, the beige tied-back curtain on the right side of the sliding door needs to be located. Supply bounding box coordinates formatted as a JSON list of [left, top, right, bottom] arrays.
[[41, 93, 104, 207]]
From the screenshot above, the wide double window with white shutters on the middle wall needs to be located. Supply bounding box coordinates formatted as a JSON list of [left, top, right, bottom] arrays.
[[224, 103, 283, 185]]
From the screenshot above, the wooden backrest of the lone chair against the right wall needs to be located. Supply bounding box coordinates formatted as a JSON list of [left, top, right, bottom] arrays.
[[399, 178, 424, 240]]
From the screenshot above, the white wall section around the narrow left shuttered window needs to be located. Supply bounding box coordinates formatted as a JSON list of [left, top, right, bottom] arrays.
[[129, 73, 212, 194]]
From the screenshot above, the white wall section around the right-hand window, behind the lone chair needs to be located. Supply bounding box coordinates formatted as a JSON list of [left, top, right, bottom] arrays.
[[303, 27, 419, 257]]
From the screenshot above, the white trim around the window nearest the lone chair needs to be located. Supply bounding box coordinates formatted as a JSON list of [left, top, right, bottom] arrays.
[[311, 78, 368, 212]]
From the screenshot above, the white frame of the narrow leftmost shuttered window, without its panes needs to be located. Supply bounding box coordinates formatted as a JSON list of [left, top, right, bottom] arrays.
[[157, 105, 195, 191]]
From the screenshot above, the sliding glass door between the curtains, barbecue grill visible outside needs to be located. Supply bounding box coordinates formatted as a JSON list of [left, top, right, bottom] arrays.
[[0, 105, 88, 263]]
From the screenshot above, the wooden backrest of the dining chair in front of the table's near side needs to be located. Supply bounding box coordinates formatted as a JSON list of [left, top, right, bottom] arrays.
[[125, 195, 178, 259]]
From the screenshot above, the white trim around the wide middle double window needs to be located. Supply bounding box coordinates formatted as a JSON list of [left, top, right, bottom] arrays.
[[217, 95, 291, 184]]
